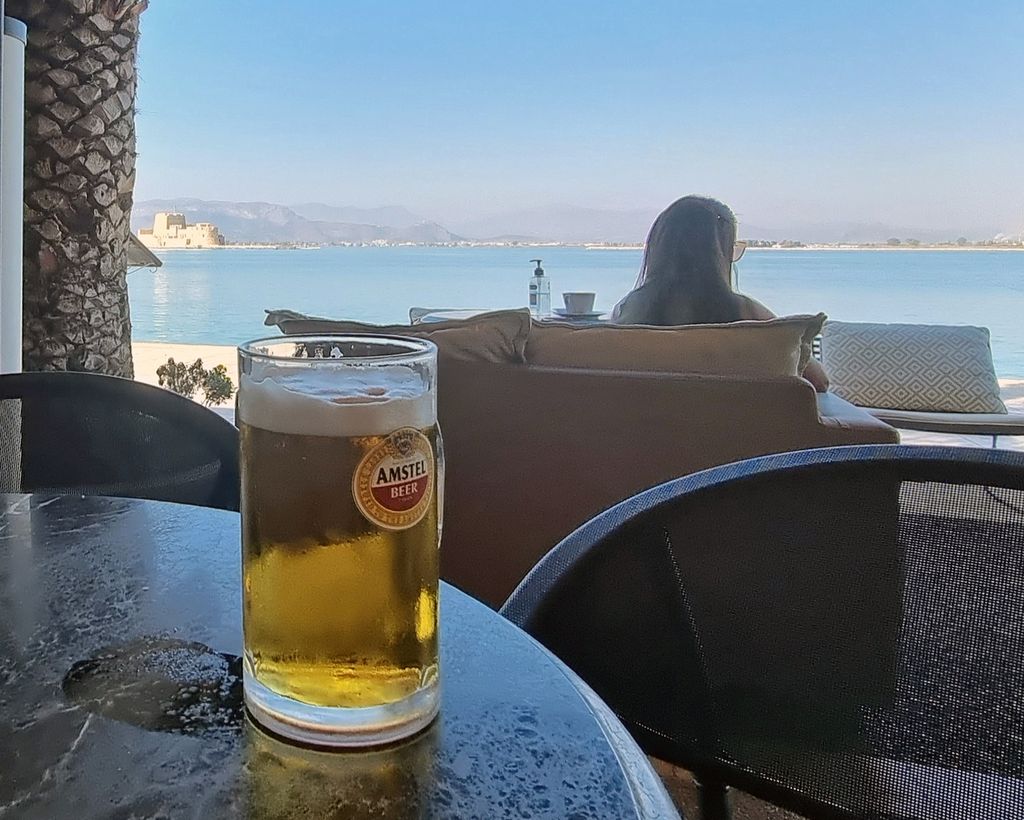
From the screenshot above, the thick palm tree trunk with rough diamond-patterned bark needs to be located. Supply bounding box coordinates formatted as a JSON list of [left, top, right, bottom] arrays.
[[6, 0, 147, 378]]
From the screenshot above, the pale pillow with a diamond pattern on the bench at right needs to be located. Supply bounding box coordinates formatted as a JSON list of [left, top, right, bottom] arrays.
[[821, 321, 1007, 413]]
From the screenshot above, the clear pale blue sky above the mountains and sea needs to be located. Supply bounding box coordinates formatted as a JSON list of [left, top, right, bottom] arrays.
[[135, 0, 1024, 236]]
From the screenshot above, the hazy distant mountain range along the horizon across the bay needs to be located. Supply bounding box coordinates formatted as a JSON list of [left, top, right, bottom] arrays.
[[132, 199, 1007, 244]]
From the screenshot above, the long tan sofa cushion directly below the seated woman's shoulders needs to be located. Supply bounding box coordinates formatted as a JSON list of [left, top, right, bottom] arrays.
[[526, 313, 825, 376]]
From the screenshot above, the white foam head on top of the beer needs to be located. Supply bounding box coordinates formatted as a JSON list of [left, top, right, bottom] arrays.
[[239, 360, 437, 436]]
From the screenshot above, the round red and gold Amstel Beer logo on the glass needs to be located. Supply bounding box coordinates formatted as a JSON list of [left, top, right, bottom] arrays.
[[352, 427, 434, 529]]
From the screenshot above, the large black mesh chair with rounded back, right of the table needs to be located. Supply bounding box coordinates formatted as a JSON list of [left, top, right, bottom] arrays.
[[502, 445, 1024, 820]]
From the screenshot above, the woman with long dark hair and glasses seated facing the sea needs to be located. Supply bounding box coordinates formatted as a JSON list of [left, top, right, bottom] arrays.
[[611, 196, 828, 392]]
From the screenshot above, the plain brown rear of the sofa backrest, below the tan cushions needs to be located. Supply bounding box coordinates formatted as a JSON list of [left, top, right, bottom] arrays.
[[438, 362, 884, 607]]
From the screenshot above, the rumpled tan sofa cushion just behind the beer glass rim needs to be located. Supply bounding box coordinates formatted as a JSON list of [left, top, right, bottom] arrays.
[[264, 309, 530, 363]]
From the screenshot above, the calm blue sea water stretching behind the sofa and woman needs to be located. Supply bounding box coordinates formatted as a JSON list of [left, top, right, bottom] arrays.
[[128, 247, 1024, 377]]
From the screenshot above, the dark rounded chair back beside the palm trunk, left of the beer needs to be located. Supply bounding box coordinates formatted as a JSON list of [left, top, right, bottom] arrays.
[[0, 372, 239, 510]]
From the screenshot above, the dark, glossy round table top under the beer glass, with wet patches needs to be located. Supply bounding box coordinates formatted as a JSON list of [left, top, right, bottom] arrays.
[[0, 495, 678, 818]]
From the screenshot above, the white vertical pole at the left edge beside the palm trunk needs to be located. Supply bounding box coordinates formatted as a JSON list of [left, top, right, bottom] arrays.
[[0, 17, 27, 373]]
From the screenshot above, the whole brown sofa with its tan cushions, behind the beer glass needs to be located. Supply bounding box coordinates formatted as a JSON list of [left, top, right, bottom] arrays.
[[266, 310, 898, 608]]
